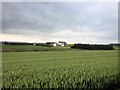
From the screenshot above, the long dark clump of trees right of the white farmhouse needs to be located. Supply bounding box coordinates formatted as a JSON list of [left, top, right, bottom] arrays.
[[71, 44, 114, 50]]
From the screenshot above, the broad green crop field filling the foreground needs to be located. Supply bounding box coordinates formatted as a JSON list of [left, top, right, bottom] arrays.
[[2, 50, 119, 88]]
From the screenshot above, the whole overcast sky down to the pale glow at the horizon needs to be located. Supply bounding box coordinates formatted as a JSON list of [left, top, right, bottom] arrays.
[[0, 2, 118, 43]]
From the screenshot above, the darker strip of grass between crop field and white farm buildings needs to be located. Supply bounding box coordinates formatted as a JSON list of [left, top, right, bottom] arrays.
[[2, 45, 71, 52]]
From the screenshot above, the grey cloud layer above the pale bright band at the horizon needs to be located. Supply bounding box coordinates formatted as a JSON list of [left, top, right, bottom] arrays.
[[2, 2, 118, 43]]
